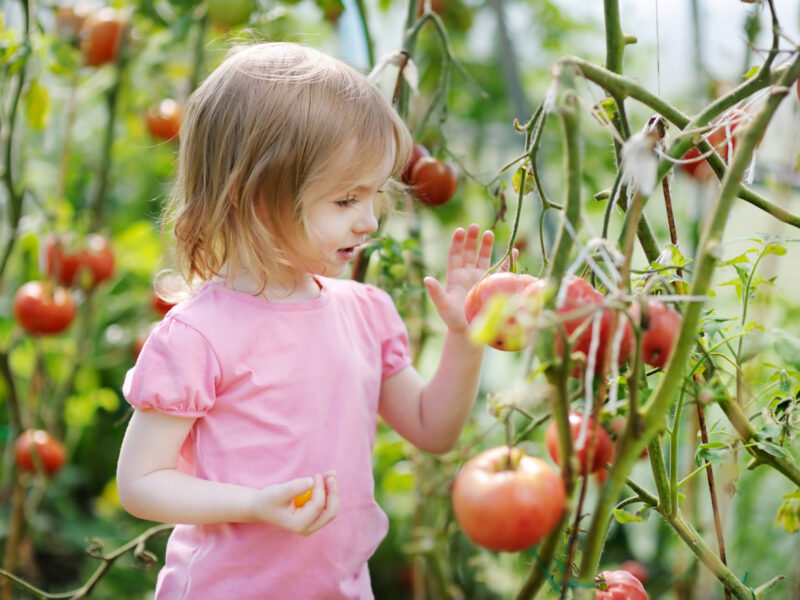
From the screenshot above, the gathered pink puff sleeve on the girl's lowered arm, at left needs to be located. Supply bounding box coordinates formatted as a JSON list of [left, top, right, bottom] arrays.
[[122, 317, 220, 417]]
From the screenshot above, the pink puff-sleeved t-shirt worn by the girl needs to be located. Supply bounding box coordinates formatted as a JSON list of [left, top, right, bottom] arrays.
[[123, 277, 410, 600]]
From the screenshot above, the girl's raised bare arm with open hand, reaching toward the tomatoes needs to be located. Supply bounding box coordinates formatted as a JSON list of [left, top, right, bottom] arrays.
[[380, 224, 494, 453]]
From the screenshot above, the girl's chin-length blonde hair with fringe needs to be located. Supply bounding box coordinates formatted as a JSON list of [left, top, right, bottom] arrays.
[[164, 43, 411, 290]]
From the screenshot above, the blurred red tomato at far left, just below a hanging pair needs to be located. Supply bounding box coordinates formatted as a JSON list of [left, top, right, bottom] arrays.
[[13, 281, 75, 335]]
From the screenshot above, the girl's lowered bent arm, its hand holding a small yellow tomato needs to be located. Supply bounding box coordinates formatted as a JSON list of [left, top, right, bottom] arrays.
[[117, 410, 339, 535]]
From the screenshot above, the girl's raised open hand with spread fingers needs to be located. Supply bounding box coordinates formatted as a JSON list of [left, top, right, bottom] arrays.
[[425, 223, 494, 333]]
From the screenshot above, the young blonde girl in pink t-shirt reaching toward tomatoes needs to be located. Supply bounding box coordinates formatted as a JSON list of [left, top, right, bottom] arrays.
[[117, 43, 493, 600]]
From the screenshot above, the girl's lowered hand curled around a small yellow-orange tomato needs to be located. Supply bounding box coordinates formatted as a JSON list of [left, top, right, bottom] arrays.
[[253, 471, 339, 535]]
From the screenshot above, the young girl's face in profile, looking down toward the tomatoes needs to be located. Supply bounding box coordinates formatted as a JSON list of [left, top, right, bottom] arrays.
[[292, 152, 393, 277]]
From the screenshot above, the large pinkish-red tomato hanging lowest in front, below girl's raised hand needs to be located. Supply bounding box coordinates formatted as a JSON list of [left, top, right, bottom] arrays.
[[452, 446, 567, 552]]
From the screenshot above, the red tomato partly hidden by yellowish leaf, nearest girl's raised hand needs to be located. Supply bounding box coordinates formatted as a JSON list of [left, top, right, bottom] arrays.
[[464, 273, 536, 352]]
